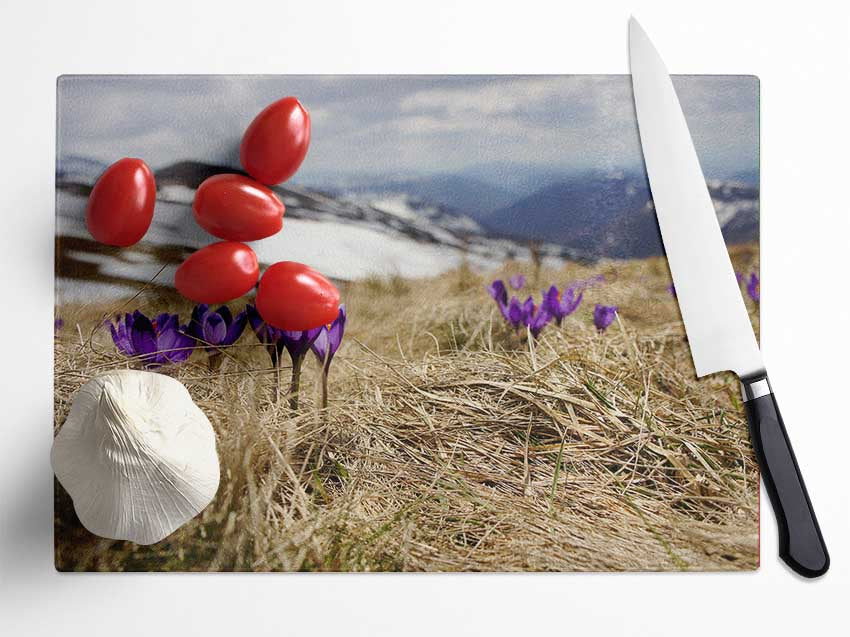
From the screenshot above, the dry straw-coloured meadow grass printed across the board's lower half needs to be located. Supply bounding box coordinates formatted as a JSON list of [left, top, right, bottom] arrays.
[[55, 247, 759, 571]]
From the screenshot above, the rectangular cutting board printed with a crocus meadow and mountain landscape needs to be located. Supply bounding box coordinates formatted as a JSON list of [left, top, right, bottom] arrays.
[[54, 76, 759, 571]]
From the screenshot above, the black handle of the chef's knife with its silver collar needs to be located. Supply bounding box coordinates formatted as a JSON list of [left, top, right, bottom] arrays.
[[742, 377, 829, 577]]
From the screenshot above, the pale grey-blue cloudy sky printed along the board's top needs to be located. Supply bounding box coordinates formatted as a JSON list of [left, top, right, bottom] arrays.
[[58, 75, 758, 182]]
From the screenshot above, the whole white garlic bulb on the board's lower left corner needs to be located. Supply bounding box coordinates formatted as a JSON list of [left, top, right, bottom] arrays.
[[50, 370, 220, 544]]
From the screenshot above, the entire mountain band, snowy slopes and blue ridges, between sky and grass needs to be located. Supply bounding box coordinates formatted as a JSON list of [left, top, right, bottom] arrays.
[[57, 157, 758, 298]]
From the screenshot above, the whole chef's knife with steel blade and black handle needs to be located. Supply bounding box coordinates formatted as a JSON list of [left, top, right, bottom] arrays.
[[629, 18, 829, 577]]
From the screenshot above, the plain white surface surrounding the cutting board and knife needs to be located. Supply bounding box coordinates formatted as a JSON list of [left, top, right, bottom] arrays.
[[0, 0, 850, 636]]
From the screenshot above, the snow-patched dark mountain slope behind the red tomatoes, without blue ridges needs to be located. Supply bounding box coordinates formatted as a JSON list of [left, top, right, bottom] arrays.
[[57, 162, 589, 300]]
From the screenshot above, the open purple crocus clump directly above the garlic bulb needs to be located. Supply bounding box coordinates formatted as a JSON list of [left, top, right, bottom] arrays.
[[109, 310, 195, 369]]
